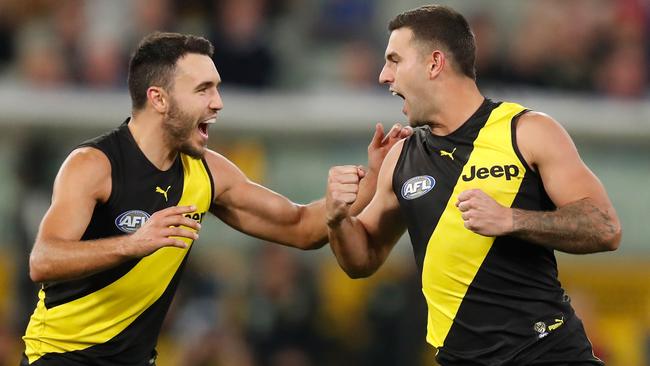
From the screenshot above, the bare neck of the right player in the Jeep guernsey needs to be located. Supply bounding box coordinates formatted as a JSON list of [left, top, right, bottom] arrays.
[[430, 77, 485, 136]]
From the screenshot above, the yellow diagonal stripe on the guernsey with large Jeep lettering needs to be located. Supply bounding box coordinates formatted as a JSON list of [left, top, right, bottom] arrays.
[[422, 103, 526, 347]]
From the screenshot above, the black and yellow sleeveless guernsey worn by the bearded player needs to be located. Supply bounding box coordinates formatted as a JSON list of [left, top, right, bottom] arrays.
[[23, 120, 213, 366]]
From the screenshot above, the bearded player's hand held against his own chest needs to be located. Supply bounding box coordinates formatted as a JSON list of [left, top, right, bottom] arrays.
[[122, 206, 201, 258]]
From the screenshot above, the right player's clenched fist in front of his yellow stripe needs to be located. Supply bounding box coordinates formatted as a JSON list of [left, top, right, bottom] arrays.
[[456, 189, 513, 236]]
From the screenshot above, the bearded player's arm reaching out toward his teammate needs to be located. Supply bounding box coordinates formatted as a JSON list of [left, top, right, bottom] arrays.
[[206, 125, 410, 249]]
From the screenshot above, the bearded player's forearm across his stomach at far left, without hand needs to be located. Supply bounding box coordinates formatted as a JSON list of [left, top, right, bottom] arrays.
[[29, 236, 130, 282]]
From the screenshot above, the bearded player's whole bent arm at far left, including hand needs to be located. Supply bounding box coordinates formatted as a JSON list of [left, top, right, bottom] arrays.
[[29, 147, 198, 282]]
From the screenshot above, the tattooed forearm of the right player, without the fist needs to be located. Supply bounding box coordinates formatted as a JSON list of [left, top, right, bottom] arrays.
[[512, 198, 621, 254]]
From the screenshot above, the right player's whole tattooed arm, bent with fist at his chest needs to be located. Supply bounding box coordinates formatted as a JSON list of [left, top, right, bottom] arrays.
[[457, 112, 621, 254]]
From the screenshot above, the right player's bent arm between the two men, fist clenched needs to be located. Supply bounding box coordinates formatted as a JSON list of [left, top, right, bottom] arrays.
[[327, 141, 405, 278]]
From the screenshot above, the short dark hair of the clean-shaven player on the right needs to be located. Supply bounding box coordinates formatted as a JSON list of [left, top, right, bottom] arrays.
[[388, 5, 476, 79]]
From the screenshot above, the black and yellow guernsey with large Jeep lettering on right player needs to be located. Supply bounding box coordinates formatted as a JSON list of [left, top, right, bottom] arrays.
[[393, 99, 582, 365]]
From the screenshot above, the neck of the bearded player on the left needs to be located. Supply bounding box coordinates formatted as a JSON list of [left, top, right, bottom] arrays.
[[129, 110, 177, 171]]
